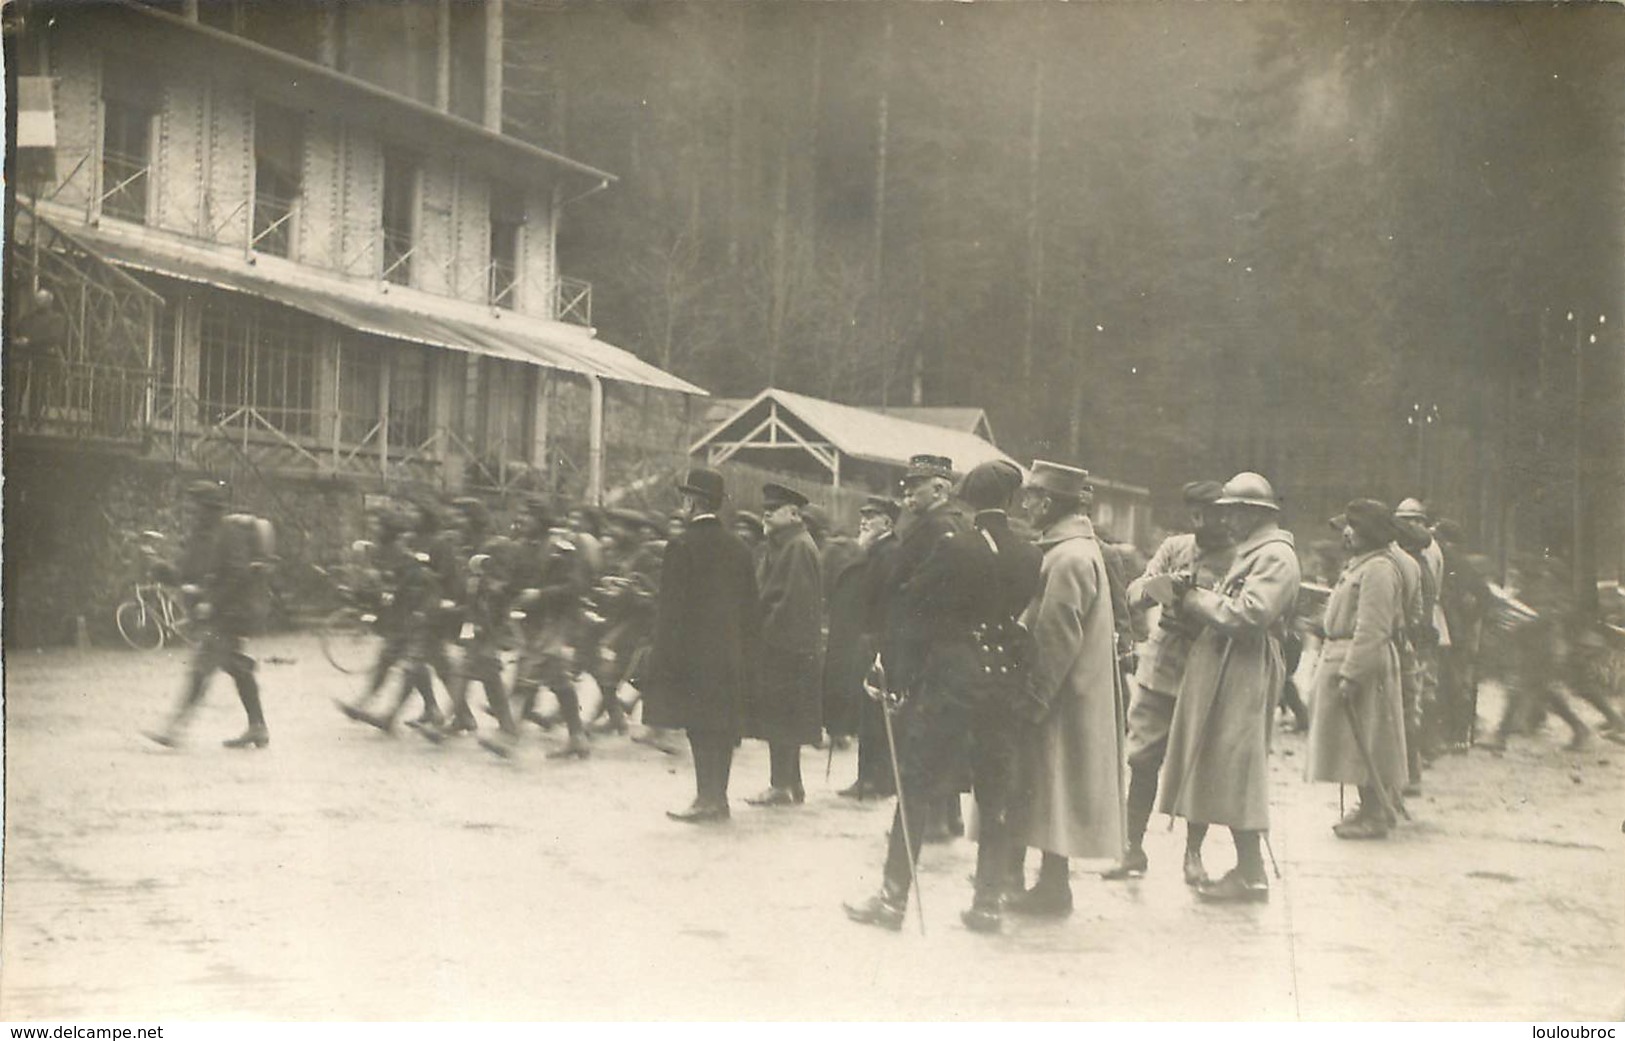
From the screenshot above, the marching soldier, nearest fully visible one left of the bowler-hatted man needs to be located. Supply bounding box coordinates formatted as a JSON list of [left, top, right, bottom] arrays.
[[514, 497, 592, 758]]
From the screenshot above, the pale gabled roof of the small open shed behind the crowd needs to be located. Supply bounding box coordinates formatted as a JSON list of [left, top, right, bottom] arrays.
[[689, 388, 1016, 473]]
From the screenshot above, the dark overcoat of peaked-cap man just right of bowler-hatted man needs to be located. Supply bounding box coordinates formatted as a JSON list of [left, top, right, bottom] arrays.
[[744, 528, 824, 744]]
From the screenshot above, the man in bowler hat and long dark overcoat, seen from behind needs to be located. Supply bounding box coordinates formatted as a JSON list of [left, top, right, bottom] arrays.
[[644, 468, 761, 823]]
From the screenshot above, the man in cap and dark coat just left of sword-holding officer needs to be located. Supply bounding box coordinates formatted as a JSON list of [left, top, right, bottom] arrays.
[[824, 495, 902, 799]]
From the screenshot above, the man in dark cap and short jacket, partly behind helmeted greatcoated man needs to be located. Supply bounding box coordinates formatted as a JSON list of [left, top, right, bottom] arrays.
[[1102, 481, 1232, 885]]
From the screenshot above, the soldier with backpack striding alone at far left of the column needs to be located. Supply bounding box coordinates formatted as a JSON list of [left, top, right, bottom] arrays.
[[146, 481, 271, 749]]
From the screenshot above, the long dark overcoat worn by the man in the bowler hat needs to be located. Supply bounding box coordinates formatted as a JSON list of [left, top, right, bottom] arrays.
[[644, 516, 761, 737]]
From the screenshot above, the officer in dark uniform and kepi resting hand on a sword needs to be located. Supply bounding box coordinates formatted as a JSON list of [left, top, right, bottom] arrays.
[[845, 455, 988, 929]]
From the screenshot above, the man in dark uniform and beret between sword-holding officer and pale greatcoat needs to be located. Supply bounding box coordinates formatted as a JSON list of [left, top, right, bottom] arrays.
[[956, 460, 1043, 932]]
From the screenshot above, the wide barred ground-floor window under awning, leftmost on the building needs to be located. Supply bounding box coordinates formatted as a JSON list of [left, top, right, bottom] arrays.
[[198, 296, 317, 437]]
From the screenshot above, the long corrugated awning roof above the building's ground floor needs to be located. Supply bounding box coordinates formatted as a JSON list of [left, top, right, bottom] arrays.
[[72, 227, 705, 395]]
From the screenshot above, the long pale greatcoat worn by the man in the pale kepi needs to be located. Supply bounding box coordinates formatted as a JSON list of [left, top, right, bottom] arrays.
[[1014, 516, 1123, 857]]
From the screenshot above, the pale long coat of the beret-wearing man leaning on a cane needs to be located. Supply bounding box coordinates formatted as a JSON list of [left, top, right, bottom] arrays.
[[1305, 549, 1406, 788]]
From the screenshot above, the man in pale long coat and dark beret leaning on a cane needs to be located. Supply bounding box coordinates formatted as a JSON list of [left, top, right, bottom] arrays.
[[1305, 499, 1406, 838]]
